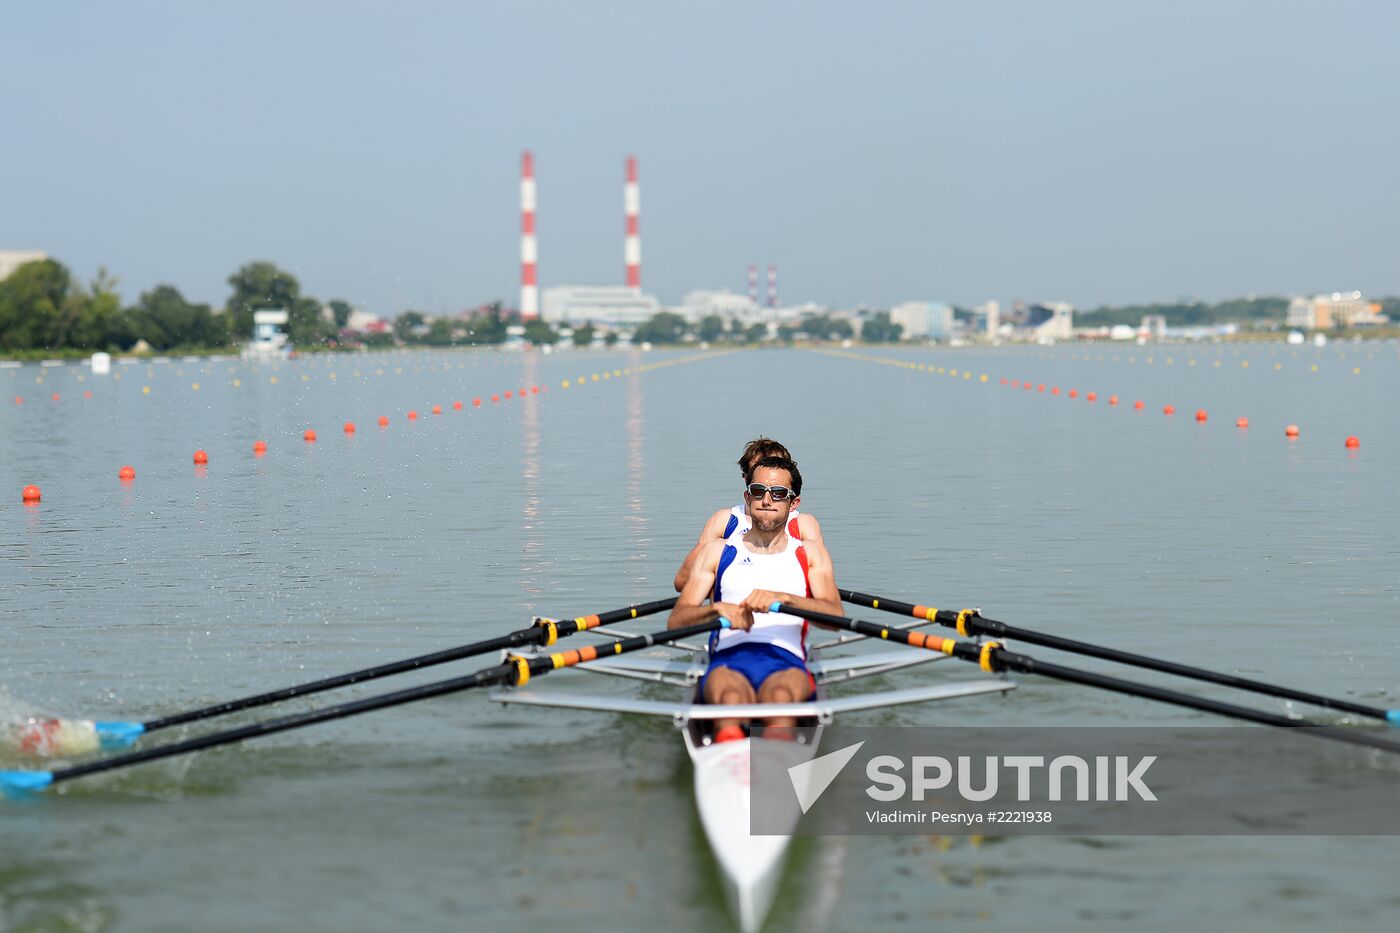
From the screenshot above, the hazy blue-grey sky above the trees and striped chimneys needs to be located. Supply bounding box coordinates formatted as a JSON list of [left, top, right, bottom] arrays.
[[0, 0, 1400, 314]]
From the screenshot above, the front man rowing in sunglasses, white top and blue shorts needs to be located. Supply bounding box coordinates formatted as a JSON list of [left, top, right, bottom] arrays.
[[666, 457, 843, 742]]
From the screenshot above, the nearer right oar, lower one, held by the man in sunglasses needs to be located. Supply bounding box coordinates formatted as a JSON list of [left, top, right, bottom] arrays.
[[771, 602, 1400, 752]]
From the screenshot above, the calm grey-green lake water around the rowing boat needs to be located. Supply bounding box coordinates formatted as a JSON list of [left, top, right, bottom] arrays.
[[0, 343, 1400, 932]]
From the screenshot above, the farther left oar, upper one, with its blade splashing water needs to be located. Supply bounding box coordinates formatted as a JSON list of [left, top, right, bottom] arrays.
[[0, 597, 676, 756]]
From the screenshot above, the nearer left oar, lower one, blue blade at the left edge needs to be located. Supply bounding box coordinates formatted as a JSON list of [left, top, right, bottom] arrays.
[[0, 619, 729, 796]]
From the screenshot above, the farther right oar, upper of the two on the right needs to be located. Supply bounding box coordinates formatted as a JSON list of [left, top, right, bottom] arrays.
[[840, 590, 1400, 726]]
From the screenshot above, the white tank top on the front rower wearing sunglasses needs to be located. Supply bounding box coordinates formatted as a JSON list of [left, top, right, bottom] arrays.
[[710, 535, 812, 661]]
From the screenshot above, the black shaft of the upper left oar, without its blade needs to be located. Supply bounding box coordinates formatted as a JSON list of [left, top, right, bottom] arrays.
[[141, 597, 676, 733]]
